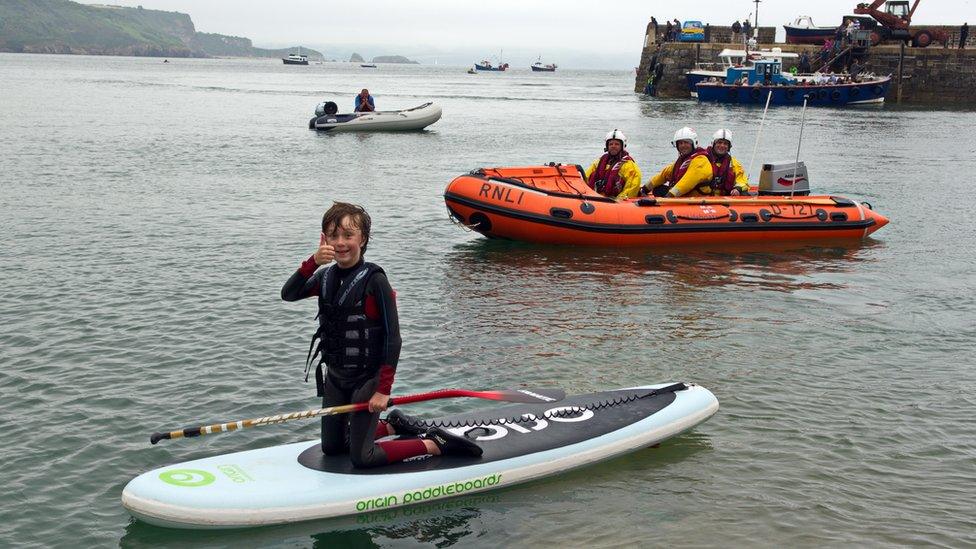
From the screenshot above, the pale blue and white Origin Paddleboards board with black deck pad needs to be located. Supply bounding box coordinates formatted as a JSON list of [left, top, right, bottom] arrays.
[[122, 383, 718, 528]]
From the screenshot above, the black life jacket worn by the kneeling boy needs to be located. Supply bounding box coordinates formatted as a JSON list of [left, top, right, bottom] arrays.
[[305, 262, 385, 396]]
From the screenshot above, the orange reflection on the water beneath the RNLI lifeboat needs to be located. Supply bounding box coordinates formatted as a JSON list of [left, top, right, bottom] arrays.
[[445, 239, 883, 296]]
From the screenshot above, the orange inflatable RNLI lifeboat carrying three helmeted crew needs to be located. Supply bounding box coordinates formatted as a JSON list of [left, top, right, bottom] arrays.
[[444, 164, 888, 246]]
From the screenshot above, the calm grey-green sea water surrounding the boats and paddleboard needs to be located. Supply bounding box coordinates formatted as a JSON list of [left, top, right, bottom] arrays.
[[0, 54, 976, 547]]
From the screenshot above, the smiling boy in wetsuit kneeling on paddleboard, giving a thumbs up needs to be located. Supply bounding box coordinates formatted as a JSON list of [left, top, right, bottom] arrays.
[[281, 202, 482, 468]]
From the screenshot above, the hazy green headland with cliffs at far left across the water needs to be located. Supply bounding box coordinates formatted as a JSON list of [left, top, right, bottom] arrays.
[[0, 0, 322, 59]]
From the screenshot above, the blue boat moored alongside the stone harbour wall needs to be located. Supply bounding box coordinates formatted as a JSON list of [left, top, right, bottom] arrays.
[[695, 59, 891, 107]]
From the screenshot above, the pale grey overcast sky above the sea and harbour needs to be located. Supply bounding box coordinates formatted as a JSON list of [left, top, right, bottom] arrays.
[[85, 0, 976, 68]]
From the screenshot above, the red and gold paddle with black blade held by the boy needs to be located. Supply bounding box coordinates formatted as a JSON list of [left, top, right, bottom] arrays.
[[149, 389, 566, 444]]
